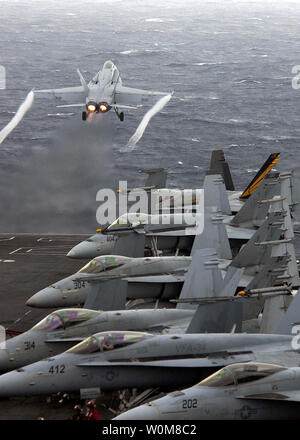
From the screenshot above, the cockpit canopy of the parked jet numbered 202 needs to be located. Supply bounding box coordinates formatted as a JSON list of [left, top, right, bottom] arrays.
[[198, 363, 286, 387]]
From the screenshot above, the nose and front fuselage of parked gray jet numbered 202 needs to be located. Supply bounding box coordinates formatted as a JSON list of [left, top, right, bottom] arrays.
[[114, 362, 300, 420]]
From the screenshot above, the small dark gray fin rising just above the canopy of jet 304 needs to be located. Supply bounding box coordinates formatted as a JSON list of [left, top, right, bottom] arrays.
[[112, 231, 145, 257]]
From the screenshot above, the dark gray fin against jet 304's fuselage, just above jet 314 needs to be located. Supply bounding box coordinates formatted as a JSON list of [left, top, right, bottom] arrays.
[[83, 278, 128, 310]]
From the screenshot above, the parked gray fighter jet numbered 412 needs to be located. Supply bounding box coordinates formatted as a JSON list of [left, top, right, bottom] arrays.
[[0, 291, 300, 397]]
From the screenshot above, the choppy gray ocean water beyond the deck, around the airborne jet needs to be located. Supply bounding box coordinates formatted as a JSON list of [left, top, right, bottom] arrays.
[[0, 0, 300, 233]]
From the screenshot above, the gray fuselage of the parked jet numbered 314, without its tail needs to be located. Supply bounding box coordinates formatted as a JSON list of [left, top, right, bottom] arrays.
[[0, 309, 194, 374]]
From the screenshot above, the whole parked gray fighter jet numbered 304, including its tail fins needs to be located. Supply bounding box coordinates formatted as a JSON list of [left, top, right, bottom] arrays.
[[27, 192, 300, 308]]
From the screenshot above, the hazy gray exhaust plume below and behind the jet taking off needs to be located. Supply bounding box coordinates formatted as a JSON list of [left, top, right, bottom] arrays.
[[0, 118, 118, 234]]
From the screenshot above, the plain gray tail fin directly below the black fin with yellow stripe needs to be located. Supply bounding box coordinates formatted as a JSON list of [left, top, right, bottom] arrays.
[[230, 173, 279, 228]]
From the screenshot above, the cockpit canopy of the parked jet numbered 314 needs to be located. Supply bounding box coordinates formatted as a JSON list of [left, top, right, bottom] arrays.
[[32, 309, 100, 332]]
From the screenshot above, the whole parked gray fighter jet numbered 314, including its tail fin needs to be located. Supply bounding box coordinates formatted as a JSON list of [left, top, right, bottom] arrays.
[[0, 249, 242, 372]]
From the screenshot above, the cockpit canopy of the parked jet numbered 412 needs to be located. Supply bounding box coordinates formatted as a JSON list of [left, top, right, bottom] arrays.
[[67, 331, 153, 354]]
